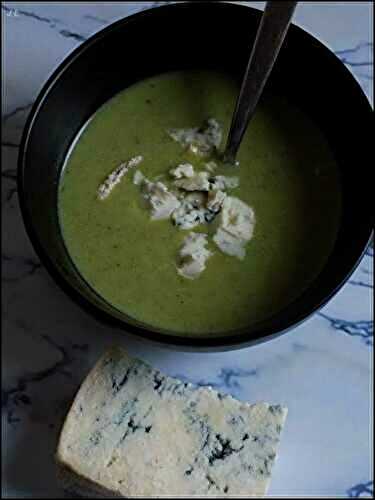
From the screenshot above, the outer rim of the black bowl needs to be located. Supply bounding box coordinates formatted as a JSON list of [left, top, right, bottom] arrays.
[[17, 1, 373, 352]]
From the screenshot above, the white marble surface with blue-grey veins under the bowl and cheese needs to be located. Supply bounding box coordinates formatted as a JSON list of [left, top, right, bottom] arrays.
[[2, 2, 373, 498]]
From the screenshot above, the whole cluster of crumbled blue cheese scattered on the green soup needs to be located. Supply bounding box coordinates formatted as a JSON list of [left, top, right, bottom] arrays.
[[98, 118, 255, 279]]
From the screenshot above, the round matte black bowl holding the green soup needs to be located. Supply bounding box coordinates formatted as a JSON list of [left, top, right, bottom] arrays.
[[18, 2, 372, 350]]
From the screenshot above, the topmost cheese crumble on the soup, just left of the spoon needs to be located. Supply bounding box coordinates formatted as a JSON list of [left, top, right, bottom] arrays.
[[168, 118, 223, 156]]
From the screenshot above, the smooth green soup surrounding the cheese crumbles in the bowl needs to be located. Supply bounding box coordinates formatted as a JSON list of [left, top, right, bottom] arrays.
[[59, 71, 341, 336]]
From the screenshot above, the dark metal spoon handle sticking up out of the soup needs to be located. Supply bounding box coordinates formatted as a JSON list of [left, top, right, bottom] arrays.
[[224, 0, 298, 164]]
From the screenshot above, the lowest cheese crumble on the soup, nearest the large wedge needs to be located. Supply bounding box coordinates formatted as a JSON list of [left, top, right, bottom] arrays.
[[177, 233, 213, 279]]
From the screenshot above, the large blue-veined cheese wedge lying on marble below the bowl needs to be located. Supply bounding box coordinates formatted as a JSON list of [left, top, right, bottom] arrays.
[[56, 348, 287, 498]]
